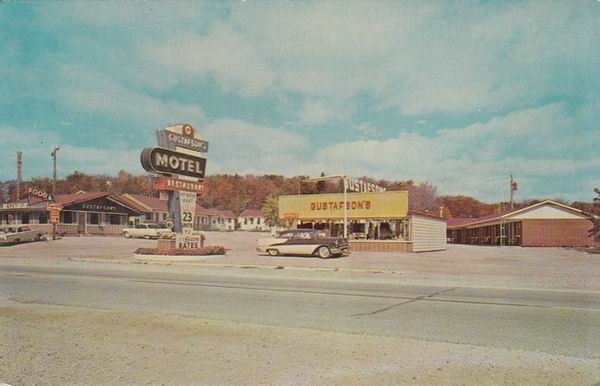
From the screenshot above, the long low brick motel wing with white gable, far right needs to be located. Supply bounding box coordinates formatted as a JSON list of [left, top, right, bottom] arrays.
[[448, 200, 594, 247]]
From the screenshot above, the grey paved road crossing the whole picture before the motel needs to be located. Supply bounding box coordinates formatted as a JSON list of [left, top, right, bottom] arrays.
[[0, 266, 600, 359]]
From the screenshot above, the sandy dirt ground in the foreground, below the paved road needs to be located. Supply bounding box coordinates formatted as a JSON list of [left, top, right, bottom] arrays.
[[0, 303, 600, 386]]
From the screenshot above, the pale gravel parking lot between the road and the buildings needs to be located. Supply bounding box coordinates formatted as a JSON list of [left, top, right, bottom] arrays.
[[0, 232, 600, 291]]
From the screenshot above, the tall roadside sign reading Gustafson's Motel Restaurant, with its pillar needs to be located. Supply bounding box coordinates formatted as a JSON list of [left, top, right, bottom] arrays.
[[141, 124, 208, 249]]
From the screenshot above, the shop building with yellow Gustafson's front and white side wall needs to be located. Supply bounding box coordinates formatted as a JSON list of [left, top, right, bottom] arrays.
[[279, 191, 447, 252]]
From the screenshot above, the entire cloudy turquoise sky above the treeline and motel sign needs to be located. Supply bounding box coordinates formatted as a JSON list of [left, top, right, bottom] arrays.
[[0, 0, 600, 202]]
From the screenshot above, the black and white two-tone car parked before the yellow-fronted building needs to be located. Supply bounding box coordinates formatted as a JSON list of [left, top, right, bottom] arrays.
[[256, 229, 350, 259]]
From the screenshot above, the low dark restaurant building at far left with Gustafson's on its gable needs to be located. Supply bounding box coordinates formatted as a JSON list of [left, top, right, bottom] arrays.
[[0, 191, 140, 236]]
